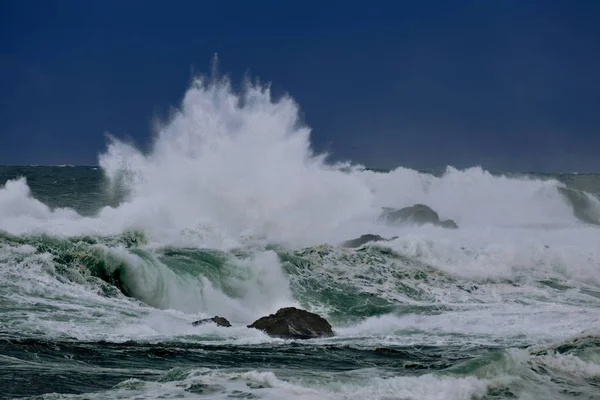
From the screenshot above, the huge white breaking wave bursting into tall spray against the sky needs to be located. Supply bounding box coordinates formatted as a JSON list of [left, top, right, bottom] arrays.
[[0, 73, 600, 248]]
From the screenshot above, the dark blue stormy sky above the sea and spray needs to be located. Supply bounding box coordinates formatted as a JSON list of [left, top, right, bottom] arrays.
[[0, 0, 600, 172]]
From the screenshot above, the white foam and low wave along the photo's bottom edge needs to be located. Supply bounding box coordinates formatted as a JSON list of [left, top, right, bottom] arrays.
[[17, 349, 600, 400]]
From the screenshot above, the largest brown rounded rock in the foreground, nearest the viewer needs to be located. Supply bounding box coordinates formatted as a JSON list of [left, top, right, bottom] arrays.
[[248, 307, 333, 339]]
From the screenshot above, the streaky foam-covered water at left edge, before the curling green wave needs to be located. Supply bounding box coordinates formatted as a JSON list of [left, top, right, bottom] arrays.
[[0, 244, 147, 338]]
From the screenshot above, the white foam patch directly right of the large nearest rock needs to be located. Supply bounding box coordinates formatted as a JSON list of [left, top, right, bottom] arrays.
[[336, 304, 600, 346]]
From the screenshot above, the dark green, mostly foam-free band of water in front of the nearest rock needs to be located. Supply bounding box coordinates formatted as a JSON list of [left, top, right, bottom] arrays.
[[0, 340, 489, 396]]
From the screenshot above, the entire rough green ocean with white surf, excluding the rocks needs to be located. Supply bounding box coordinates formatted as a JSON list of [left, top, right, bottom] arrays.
[[0, 79, 600, 400]]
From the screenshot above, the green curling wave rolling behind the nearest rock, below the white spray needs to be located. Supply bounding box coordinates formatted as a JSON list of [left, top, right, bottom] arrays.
[[0, 231, 600, 326]]
